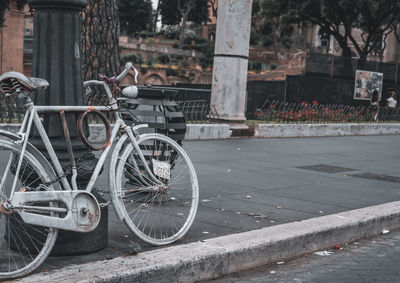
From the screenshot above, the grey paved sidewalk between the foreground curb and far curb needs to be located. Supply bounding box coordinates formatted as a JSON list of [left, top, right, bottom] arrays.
[[14, 135, 400, 282]]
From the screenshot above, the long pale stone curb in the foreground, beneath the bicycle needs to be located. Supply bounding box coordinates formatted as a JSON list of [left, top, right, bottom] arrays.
[[17, 201, 400, 283]]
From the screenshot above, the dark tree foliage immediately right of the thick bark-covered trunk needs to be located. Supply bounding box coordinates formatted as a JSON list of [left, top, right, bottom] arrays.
[[118, 0, 153, 34]]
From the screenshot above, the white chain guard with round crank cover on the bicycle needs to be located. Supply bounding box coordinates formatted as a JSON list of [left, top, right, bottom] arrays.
[[11, 191, 100, 232]]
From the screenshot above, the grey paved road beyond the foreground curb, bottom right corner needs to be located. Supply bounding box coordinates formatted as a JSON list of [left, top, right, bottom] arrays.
[[208, 230, 400, 283]]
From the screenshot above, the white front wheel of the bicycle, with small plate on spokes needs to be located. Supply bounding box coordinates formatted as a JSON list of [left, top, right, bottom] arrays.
[[116, 134, 199, 246]]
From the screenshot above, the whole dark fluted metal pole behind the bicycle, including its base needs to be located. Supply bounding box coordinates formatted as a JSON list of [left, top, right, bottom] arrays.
[[28, 0, 108, 255]]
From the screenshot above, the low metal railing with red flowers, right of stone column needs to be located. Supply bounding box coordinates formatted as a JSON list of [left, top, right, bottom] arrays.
[[246, 100, 400, 123]]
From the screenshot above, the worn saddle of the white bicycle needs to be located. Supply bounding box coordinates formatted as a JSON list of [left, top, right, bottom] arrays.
[[0, 72, 49, 92]]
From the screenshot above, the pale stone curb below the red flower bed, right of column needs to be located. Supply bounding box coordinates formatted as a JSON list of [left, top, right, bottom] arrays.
[[254, 123, 400, 138]]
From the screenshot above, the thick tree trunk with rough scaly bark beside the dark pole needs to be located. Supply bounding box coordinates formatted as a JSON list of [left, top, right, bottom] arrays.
[[82, 0, 120, 80]]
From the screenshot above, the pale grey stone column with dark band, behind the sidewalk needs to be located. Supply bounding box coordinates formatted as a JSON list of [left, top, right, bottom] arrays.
[[211, 0, 252, 124]]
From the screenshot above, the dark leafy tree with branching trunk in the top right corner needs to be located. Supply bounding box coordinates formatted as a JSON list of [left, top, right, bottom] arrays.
[[261, 0, 400, 59]]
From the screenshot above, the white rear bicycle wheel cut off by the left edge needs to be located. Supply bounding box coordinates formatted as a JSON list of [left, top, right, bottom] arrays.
[[0, 139, 57, 279]]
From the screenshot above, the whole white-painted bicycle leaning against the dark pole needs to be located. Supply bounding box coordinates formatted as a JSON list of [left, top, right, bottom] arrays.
[[0, 63, 199, 279]]
